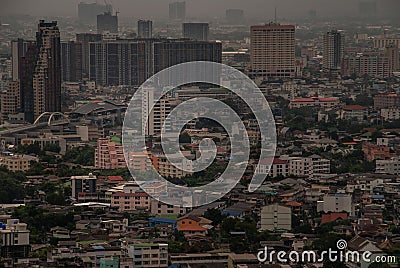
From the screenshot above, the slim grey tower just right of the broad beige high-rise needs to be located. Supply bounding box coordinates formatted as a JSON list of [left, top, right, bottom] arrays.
[[323, 30, 344, 70]]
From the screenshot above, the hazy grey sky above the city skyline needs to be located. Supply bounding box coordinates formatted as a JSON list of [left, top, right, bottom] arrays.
[[0, 0, 400, 19]]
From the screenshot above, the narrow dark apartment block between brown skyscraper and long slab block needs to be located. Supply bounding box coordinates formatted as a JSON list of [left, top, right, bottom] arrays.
[[61, 41, 83, 82]]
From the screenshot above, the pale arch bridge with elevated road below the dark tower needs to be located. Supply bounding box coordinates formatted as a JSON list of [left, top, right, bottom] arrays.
[[0, 112, 70, 136]]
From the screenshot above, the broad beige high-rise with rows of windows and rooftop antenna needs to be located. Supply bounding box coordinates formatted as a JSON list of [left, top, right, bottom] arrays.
[[250, 23, 295, 78]]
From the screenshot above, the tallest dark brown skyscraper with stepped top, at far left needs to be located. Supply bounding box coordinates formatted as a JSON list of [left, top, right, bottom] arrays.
[[33, 20, 61, 118]]
